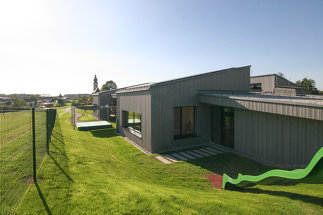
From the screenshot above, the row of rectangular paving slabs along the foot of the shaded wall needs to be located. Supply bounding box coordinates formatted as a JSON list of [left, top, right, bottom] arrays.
[[155, 146, 223, 164]]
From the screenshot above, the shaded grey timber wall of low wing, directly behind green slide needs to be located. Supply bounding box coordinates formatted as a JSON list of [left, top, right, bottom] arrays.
[[234, 109, 323, 168]]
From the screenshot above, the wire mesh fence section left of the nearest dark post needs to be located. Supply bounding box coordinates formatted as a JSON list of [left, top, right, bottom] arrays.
[[0, 108, 33, 214]]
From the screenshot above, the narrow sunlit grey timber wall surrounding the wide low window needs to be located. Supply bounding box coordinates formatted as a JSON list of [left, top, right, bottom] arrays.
[[117, 91, 151, 151]]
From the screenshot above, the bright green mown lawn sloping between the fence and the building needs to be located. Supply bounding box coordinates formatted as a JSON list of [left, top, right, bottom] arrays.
[[17, 112, 323, 215]]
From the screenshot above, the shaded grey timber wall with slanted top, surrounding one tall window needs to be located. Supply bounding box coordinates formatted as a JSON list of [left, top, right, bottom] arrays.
[[150, 66, 250, 152]]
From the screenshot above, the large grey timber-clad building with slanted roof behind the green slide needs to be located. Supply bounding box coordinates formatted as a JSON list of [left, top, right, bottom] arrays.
[[95, 66, 323, 167]]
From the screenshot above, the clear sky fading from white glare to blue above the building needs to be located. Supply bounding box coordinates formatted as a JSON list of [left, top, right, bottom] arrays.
[[0, 0, 323, 95]]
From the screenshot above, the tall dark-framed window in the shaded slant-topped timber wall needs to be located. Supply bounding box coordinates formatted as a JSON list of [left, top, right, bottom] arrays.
[[174, 107, 195, 139]]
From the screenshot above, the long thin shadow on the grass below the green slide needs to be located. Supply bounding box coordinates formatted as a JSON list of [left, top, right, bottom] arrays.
[[236, 188, 323, 206]]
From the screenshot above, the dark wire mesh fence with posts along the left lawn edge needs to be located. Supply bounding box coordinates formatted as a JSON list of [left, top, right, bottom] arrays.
[[0, 107, 56, 214]]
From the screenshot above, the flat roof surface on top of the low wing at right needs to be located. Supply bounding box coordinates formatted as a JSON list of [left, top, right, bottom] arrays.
[[198, 91, 323, 108]]
